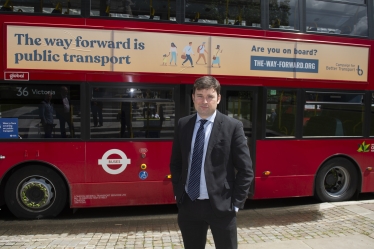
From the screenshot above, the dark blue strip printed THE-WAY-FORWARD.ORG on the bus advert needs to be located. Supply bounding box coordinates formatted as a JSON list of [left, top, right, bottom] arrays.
[[251, 56, 318, 73]]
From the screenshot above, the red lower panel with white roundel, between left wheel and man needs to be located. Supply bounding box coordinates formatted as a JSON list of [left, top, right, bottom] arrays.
[[77, 142, 175, 207]]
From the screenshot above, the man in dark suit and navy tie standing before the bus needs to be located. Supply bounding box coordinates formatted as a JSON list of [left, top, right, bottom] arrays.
[[170, 76, 253, 249]]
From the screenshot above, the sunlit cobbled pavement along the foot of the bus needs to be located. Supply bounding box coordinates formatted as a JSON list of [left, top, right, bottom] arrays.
[[0, 197, 374, 249]]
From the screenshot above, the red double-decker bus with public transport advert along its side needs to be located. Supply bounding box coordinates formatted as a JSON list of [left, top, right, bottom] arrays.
[[0, 0, 374, 218]]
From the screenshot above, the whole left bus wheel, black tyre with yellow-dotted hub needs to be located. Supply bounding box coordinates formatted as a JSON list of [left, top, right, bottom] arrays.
[[4, 165, 67, 219]]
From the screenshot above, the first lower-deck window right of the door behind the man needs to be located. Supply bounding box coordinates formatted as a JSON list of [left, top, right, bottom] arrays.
[[266, 89, 296, 137]]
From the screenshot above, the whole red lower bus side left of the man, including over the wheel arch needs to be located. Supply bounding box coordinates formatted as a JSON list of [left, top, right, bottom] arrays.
[[0, 142, 175, 207]]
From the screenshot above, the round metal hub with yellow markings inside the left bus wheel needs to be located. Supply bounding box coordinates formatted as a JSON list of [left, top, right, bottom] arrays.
[[20, 178, 54, 209]]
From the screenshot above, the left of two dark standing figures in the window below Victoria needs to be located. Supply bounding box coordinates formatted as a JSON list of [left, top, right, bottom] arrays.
[[39, 92, 54, 138]]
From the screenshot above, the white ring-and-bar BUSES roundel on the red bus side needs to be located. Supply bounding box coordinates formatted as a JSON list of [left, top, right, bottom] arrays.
[[99, 149, 131, 175]]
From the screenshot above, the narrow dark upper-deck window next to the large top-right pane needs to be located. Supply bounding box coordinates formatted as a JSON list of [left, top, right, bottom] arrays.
[[269, 0, 300, 30]]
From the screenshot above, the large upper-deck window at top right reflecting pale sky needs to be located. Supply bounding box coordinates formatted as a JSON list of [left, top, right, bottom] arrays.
[[306, 0, 368, 36]]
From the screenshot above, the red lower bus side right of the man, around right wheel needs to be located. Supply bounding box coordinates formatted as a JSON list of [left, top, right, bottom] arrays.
[[254, 139, 374, 199]]
